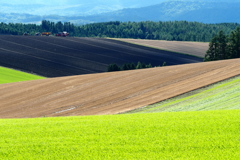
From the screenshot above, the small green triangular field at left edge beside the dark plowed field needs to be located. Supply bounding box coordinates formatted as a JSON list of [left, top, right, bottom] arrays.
[[0, 67, 44, 84]]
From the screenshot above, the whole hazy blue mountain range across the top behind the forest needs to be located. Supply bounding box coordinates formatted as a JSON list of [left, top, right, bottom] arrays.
[[0, 0, 240, 24]]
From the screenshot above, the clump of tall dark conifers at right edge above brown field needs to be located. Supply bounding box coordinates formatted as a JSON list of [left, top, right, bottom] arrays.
[[204, 27, 240, 61]]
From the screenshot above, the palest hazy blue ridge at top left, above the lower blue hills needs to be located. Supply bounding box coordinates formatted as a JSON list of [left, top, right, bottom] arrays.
[[0, 0, 165, 16]]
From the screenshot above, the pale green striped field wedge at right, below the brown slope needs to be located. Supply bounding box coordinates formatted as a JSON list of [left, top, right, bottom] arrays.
[[130, 76, 240, 113]]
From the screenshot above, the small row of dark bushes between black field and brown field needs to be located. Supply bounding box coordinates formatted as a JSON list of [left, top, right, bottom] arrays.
[[107, 62, 166, 72]]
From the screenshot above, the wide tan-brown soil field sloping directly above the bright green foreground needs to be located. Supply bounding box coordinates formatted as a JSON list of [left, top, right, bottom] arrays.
[[0, 59, 240, 118]]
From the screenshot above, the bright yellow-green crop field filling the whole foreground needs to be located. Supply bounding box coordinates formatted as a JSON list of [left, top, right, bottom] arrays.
[[0, 110, 240, 160]]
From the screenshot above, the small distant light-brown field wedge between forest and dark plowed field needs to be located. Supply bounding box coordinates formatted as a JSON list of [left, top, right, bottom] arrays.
[[116, 38, 209, 57]]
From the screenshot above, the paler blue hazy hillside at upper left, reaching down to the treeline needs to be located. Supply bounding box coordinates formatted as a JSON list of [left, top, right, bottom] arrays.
[[0, 0, 165, 23]]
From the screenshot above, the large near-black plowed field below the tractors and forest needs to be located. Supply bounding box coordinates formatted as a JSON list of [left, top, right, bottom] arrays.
[[0, 36, 202, 77]]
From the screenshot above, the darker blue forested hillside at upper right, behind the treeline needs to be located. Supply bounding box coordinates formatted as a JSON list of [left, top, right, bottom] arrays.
[[83, 1, 240, 23]]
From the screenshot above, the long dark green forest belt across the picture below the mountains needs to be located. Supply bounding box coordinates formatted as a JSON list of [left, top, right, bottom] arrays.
[[0, 20, 240, 42]]
